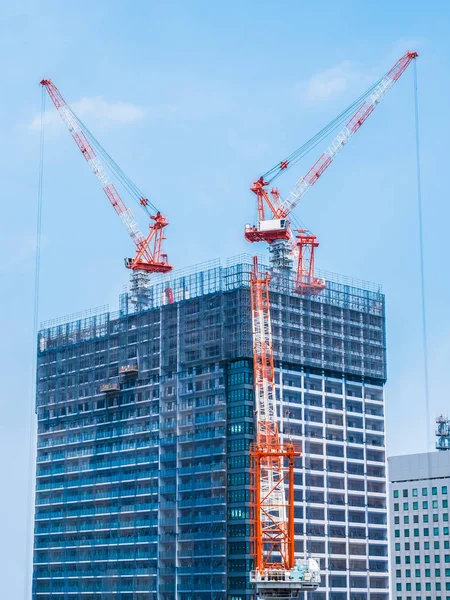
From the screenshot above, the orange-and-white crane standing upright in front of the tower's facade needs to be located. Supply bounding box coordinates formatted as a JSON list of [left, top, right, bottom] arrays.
[[250, 258, 320, 600]]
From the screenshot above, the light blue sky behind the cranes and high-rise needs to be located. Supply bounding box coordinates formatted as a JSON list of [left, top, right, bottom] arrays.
[[0, 0, 450, 600]]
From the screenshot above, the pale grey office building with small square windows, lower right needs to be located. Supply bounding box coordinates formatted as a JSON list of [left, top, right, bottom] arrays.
[[389, 452, 450, 600]]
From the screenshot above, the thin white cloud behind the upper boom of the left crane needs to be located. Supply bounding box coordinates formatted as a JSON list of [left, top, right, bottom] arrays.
[[30, 96, 148, 131]]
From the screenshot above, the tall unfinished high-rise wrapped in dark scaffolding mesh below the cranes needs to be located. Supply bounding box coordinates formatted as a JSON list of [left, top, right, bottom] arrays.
[[33, 256, 388, 600]]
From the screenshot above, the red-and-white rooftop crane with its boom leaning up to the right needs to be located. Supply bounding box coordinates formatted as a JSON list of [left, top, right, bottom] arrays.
[[244, 52, 418, 295]]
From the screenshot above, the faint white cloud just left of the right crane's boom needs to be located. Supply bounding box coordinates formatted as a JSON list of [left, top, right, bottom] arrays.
[[296, 60, 361, 104]]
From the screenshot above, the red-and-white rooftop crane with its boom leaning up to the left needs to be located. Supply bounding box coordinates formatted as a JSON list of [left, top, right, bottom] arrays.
[[40, 79, 173, 273]]
